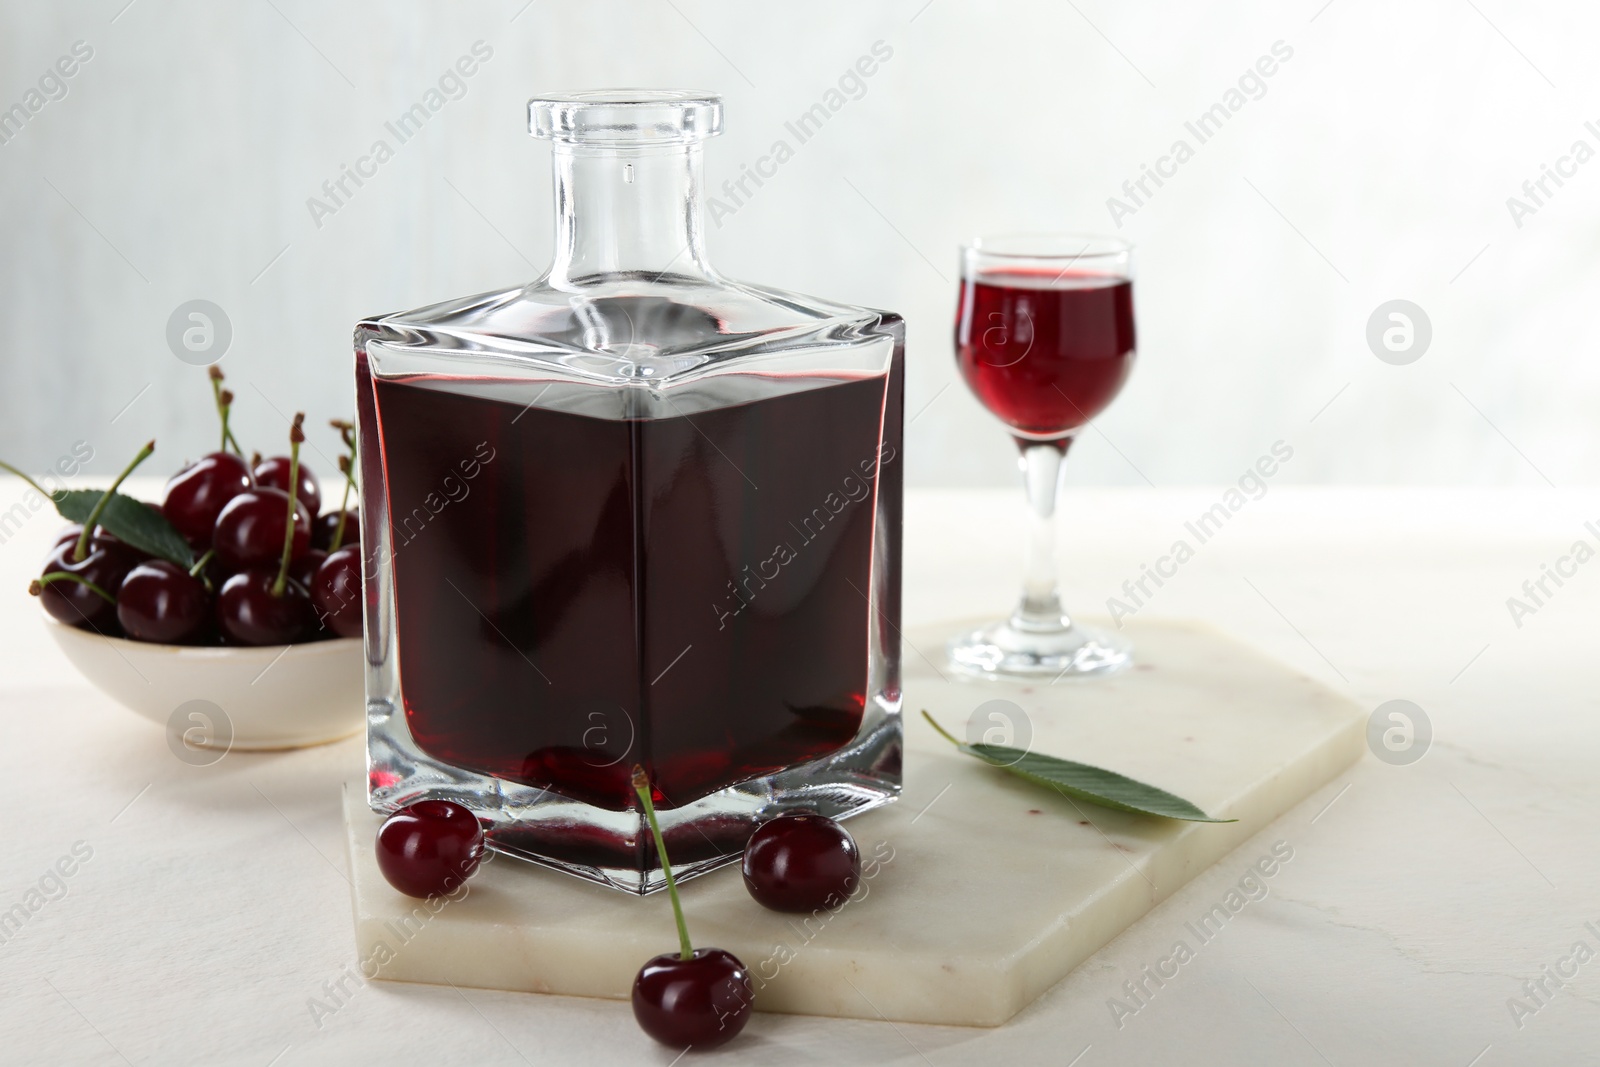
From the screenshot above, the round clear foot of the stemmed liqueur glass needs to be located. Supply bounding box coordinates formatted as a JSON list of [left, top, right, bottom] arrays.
[[946, 619, 1133, 681]]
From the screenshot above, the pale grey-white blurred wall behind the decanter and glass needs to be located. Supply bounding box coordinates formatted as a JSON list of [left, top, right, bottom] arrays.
[[0, 0, 1580, 485]]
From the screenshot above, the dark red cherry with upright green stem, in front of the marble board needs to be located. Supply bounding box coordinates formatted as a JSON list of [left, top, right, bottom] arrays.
[[634, 949, 754, 1049]]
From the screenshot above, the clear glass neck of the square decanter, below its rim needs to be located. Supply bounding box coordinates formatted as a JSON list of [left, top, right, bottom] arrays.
[[549, 142, 715, 286]]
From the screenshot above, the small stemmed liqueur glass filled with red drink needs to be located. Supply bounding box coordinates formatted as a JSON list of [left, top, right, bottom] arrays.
[[949, 234, 1134, 680]]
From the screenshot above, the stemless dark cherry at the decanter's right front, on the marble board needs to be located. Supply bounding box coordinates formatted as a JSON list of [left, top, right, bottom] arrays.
[[744, 814, 861, 912]]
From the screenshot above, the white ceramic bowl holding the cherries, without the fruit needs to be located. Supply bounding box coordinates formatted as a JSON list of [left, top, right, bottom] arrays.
[[46, 619, 366, 749]]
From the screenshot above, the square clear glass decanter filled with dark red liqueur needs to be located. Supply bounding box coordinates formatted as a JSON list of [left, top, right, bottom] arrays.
[[355, 90, 904, 893]]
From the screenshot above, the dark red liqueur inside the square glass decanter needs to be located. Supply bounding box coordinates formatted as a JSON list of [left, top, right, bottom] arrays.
[[373, 376, 885, 809]]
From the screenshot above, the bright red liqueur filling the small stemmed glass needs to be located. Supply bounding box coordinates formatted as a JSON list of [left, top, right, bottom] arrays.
[[955, 270, 1134, 440]]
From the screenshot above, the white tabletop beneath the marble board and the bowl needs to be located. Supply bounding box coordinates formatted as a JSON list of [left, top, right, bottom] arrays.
[[0, 480, 1600, 1067]]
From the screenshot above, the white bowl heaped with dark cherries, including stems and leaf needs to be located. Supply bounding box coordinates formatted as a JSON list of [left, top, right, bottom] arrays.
[[13, 368, 365, 749]]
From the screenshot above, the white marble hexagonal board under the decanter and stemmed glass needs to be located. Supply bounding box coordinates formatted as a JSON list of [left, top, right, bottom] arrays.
[[346, 622, 1365, 1027]]
